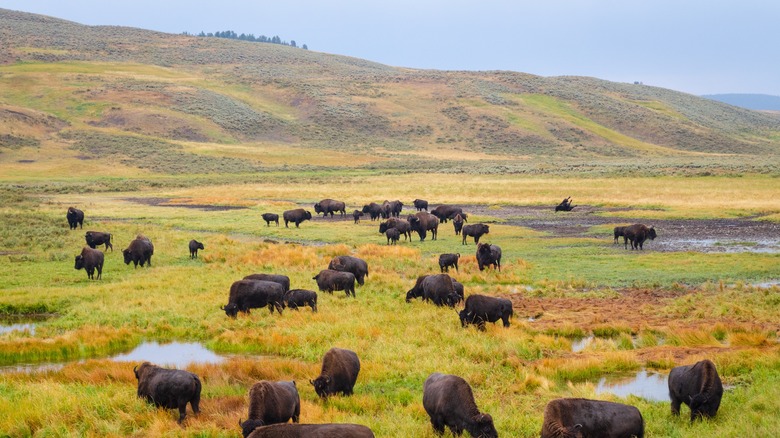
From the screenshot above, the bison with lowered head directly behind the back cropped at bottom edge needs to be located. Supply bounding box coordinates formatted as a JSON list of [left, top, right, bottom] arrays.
[[238, 380, 301, 437]]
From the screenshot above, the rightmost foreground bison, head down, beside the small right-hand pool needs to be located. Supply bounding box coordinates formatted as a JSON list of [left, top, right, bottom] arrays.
[[669, 359, 723, 421]]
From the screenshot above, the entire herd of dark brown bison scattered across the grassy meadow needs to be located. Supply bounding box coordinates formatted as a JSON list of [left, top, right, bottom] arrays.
[[62, 197, 723, 438]]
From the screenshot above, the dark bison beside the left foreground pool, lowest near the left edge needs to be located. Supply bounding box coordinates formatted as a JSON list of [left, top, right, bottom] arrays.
[[133, 362, 201, 423]]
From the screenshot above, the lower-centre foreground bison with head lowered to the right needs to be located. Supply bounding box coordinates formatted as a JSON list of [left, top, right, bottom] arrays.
[[423, 373, 498, 438]]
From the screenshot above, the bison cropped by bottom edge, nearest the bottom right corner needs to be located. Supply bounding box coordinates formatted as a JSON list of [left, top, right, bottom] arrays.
[[542, 398, 645, 438]]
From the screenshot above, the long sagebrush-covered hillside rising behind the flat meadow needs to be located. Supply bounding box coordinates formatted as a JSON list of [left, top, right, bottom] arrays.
[[0, 9, 780, 173]]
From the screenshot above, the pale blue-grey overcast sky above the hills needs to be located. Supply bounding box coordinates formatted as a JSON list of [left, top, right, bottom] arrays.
[[0, 0, 780, 96]]
